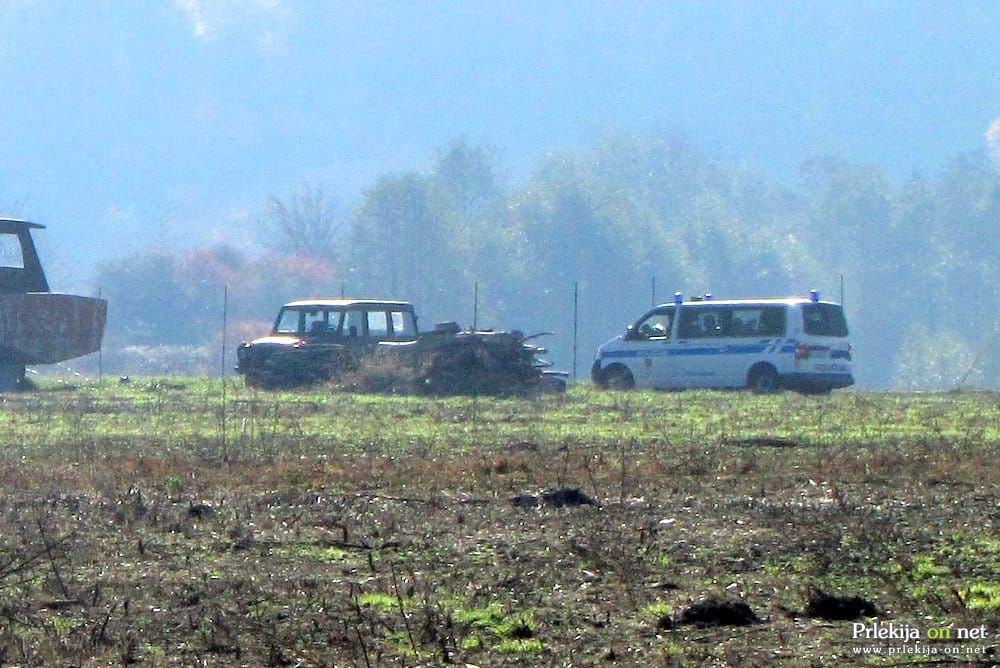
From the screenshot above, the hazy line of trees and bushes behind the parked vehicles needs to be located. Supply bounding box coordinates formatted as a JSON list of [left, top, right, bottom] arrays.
[[95, 136, 1000, 388]]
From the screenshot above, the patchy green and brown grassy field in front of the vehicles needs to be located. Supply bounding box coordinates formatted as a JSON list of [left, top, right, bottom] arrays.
[[0, 379, 1000, 666]]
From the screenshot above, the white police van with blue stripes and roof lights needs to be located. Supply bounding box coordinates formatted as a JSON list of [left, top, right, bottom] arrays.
[[591, 290, 854, 394]]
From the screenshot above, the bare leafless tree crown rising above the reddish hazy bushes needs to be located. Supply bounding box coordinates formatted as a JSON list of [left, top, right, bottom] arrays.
[[258, 185, 342, 258]]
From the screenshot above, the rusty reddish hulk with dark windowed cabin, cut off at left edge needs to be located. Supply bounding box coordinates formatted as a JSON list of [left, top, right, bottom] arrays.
[[0, 218, 107, 391]]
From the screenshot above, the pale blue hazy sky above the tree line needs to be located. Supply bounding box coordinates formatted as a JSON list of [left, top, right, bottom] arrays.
[[0, 0, 1000, 280]]
